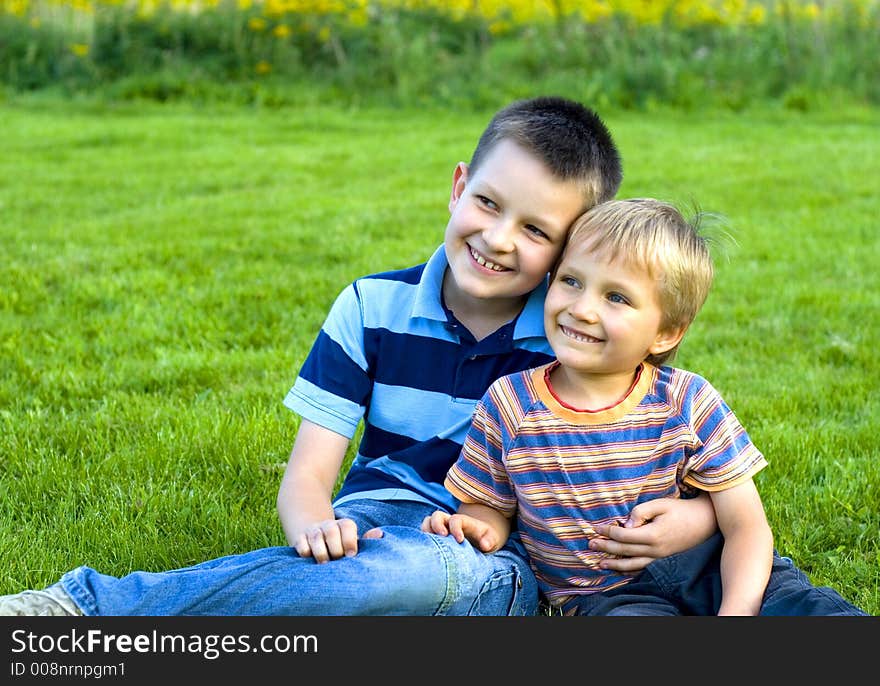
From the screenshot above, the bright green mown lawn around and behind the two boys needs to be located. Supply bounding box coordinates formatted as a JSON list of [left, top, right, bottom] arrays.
[[0, 98, 880, 614]]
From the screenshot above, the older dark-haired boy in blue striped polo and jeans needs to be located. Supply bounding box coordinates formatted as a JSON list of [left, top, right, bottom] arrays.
[[0, 98, 715, 615]]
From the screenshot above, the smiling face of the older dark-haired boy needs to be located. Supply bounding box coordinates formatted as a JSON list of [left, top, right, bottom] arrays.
[[444, 140, 585, 316]]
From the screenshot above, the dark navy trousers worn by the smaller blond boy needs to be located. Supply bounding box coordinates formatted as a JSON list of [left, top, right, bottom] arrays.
[[577, 534, 867, 617]]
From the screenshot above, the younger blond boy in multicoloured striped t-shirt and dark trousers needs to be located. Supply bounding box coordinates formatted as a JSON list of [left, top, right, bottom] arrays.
[[423, 199, 860, 615]]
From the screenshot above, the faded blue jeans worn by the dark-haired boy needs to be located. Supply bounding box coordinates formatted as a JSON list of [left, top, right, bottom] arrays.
[[61, 500, 538, 616]]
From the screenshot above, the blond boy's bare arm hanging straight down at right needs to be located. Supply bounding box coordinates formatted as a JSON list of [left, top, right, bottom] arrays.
[[709, 479, 773, 615]]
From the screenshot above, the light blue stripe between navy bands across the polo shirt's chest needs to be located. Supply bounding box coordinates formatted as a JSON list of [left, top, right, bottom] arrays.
[[369, 383, 477, 443]]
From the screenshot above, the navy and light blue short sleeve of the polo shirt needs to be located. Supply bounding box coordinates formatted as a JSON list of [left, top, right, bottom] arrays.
[[284, 284, 372, 438]]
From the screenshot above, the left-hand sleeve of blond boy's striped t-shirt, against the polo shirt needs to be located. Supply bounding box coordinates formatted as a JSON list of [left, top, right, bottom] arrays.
[[444, 388, 516, 517]]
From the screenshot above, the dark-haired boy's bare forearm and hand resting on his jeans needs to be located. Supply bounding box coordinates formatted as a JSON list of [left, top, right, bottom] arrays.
[[277, 419, 358, 562]]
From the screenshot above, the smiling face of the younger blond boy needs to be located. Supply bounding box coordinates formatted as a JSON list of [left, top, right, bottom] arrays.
[[544, 243, 684, 388]]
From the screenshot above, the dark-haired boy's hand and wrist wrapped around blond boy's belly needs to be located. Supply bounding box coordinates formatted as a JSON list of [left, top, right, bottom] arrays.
[[590, 493, 718, 572]]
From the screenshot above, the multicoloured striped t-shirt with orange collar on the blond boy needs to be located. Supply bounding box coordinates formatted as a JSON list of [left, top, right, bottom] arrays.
[[446, 362, 767, 609]]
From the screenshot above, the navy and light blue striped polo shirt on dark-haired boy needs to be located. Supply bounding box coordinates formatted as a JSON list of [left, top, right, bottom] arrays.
[[284, 245, 553, 511]]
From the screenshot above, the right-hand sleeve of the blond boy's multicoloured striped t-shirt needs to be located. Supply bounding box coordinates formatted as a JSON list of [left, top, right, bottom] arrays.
[[684, 377, 767, 491]]
